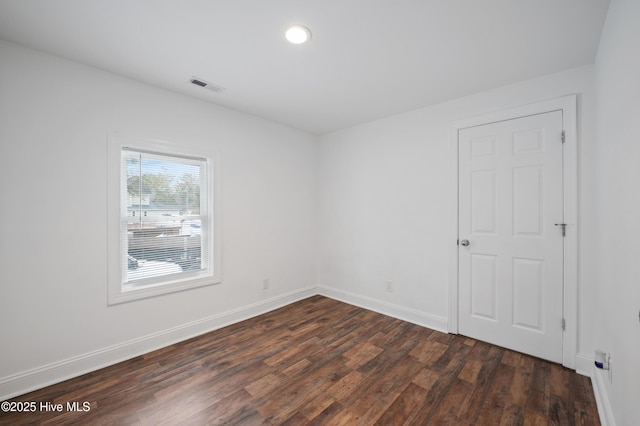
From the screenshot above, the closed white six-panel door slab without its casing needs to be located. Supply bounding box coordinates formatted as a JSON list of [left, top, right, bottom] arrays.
[[458, 111, 563, 363]]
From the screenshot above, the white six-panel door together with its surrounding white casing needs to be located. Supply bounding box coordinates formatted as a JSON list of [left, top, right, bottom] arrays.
[[448, 96, 577, 368]]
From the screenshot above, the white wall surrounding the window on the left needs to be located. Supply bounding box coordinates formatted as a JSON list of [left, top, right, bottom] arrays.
[[0, 42, 317, 400]]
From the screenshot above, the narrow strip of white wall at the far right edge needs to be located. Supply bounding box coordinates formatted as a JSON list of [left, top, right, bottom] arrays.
[[595, 0, 640, 425]]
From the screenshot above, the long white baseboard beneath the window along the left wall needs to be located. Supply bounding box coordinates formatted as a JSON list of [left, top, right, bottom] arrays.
[[0, 287, 317, 401]]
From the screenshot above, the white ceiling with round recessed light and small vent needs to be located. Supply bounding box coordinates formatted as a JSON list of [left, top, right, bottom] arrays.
[[0, 0, 609, 134]]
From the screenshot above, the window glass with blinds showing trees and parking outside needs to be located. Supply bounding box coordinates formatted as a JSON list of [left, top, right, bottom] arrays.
[[123, 150, 206, 283]]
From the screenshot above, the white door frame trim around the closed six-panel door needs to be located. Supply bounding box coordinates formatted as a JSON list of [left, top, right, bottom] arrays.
[[447, 95, 578, 370]]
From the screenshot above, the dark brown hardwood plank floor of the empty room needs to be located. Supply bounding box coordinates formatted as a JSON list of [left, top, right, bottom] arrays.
[[0, 296, 599, 425]]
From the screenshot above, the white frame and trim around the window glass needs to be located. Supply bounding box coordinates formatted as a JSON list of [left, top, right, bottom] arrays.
[[107, 133, 222, 305]]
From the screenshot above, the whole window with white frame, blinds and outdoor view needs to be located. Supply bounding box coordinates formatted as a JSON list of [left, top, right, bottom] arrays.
[[109, 136, 220, 304]]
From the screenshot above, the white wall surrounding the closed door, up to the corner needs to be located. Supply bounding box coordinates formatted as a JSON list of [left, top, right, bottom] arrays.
[[318, 67, 595, 369]]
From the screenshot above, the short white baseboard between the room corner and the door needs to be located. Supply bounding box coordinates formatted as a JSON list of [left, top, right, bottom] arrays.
[[317, 286, 447, 333]]
